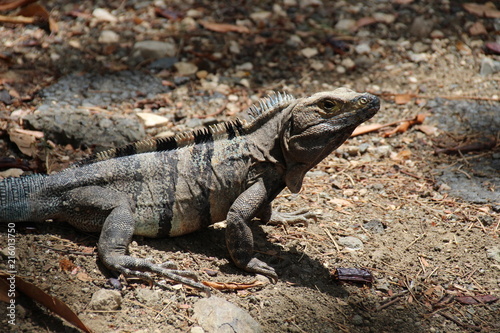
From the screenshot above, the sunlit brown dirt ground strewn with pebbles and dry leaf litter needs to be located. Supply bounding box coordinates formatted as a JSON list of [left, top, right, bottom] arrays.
[[0, 0, 500, 332]]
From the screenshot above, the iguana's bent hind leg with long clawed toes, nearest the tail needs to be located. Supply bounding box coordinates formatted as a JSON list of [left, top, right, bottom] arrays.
[[66, 186, 209, 293]]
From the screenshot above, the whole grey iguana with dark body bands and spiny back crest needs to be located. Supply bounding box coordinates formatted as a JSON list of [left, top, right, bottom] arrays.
[[0, 88, 380, 291]]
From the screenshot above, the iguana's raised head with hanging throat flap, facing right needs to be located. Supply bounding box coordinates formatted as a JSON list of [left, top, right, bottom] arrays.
[[282, 88, 380, 193]]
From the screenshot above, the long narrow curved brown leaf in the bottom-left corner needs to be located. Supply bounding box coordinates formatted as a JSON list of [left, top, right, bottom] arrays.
[[0, 271, 92, 333]]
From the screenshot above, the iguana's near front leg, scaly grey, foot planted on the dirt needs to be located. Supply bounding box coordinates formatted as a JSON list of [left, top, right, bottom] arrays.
[[226, 181, 278, 281]]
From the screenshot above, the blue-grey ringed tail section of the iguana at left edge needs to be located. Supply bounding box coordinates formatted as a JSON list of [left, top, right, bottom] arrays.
[[0, 175, 47, 222]]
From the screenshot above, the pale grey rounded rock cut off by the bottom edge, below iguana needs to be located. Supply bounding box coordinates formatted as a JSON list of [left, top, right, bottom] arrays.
[[193, 296, 263, 333]]
